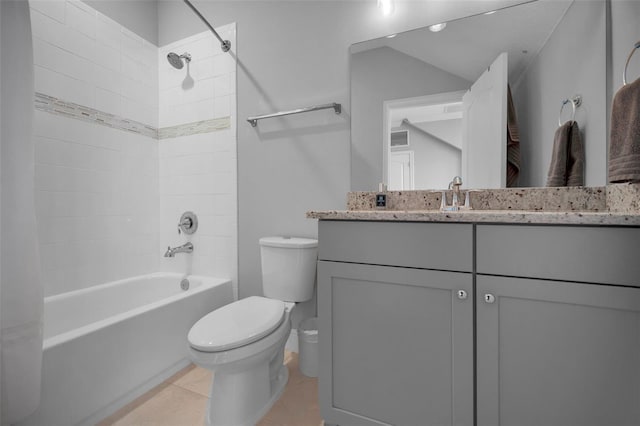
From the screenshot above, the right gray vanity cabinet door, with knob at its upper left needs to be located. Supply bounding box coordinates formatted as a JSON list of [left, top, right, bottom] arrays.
[[476, 275, 640, 426]]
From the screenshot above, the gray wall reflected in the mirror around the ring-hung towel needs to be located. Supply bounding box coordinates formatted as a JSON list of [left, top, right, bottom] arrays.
[[512, 1, 608, 186]]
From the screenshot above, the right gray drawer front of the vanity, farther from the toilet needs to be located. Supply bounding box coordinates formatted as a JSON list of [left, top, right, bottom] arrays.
[[476, 225, 640, 287]]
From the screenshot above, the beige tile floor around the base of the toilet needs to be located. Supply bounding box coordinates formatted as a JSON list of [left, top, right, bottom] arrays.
[[98, 352, 323, 426]]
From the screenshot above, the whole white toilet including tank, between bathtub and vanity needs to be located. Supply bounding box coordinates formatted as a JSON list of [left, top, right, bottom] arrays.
[[188, 237, 318, 426]]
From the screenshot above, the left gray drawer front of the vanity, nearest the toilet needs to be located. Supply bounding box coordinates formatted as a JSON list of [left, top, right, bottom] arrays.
[[318, 220, 473, 272]]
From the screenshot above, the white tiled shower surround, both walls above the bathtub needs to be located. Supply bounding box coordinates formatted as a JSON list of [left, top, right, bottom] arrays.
[[30, 0, 237, 296]]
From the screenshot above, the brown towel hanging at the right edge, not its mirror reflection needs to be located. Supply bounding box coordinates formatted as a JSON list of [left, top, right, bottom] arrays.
[[609, 79, 640, 183]]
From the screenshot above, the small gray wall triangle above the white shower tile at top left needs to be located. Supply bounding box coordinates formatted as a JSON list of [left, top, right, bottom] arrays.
[[83, 0, 158, 46]]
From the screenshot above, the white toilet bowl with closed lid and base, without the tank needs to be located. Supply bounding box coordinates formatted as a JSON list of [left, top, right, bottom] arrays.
[[188, 296, 294, 426]]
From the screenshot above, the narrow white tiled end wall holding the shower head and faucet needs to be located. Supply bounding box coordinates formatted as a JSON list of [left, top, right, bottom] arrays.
[[158, 24, 238, 292]]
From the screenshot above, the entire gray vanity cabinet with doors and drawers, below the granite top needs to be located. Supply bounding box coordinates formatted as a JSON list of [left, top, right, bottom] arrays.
[[318, 221, 640, 426]]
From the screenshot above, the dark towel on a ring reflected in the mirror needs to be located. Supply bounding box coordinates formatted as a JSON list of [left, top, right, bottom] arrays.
[[547, 121, 584, 186]]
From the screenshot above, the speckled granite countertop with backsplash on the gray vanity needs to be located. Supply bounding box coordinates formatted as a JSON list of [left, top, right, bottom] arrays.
[[307, 184, 640, 226]]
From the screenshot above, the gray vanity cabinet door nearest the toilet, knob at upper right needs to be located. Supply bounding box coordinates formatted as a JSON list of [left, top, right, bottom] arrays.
[[318, 261, 473, 426]]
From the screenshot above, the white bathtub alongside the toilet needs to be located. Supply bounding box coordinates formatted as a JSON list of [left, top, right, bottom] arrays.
[[20, 273, 233, 426]]
